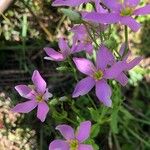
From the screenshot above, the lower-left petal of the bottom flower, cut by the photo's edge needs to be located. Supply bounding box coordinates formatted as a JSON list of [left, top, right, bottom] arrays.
[[49, 140, 69, 150]]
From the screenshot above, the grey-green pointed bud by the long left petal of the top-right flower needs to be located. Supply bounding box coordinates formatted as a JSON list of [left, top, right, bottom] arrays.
[[60, 8, 82, 23]]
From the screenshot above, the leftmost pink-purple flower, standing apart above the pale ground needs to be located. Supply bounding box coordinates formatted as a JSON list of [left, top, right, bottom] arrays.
[[12, 70, 52, 122]]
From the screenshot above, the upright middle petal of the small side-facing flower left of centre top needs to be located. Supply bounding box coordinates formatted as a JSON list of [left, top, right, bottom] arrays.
[[58, 38, 71, 57]]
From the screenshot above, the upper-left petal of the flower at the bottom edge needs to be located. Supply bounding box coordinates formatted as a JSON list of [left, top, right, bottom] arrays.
[[56, 125, 75, 140]]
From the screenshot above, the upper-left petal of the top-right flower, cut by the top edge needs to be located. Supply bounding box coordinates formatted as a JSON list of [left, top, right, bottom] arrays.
[[103, 0, 122, 11]]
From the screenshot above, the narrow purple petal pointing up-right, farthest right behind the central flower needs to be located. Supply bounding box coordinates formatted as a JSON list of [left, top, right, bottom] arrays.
[[125, 57, 142, 71]]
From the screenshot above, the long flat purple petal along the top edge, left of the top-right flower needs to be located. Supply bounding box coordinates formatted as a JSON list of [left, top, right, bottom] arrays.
[[52, 0, 90, 7]]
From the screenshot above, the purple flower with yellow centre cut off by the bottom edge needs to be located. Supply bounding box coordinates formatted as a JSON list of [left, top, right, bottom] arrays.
[[49, 121, 93, 150]]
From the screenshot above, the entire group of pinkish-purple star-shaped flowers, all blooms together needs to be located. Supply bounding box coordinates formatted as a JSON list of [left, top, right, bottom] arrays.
[[12, 0, 150, 150]]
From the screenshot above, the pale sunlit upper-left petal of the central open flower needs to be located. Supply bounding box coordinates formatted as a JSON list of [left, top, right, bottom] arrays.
[[73, 58, 96, 75]]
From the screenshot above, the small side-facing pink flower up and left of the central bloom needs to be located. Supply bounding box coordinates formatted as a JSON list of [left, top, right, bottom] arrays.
[[44, 38, 89, 61]]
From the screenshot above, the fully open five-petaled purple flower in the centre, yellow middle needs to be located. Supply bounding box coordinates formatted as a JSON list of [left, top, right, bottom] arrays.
[[73, 45, 126, 107]]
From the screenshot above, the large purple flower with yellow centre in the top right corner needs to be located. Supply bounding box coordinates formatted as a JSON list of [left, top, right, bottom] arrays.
[[84, 0, 150, 32]]
